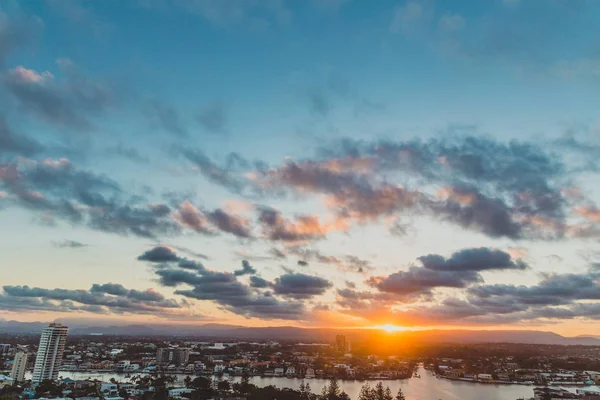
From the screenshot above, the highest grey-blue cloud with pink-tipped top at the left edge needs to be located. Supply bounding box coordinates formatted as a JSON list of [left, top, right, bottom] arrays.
[[2, 63, 116, 131]]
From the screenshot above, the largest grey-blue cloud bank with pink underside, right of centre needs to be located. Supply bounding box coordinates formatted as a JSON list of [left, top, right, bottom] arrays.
[[255, 134, 574, 239]]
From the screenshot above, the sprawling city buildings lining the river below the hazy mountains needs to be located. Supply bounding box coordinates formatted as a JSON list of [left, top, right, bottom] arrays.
[[0, 324, 600, 400]]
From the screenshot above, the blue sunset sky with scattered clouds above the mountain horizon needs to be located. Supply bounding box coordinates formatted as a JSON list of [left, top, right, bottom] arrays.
[[0, 0, 600, 336]]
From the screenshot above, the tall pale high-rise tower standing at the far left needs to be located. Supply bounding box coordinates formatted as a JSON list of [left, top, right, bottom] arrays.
[[33, 324, 69, 383]]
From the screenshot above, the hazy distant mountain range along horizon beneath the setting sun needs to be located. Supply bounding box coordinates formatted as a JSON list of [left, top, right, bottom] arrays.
[[0, 319, 600, 346]]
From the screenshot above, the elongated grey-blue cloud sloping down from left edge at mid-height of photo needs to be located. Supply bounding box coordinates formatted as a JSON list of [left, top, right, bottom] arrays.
[[0, 159, 180, 238]]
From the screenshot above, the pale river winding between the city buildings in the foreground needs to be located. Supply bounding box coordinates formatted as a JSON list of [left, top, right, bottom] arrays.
[[47, 368, 600, 400]]
